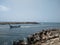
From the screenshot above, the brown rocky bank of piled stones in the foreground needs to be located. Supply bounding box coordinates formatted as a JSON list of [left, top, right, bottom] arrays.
[[13, 29, 60, 45]]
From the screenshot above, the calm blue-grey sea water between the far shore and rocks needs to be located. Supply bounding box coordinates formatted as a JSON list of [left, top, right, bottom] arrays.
[[0, 23, 60, 45]]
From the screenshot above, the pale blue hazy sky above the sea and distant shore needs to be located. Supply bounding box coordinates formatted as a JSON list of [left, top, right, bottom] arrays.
[[0, 0, 60, 22]]
